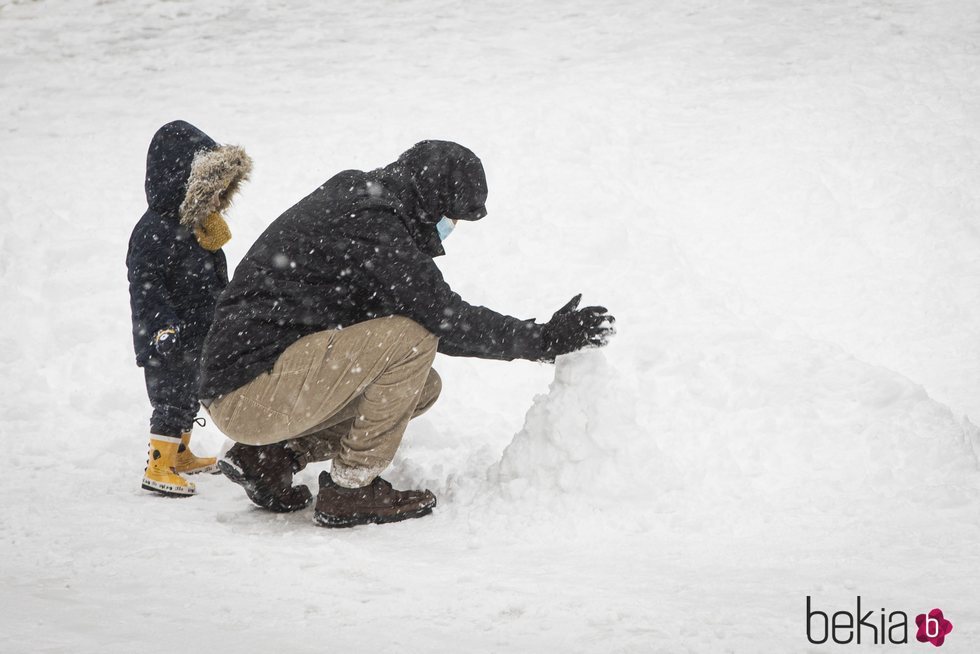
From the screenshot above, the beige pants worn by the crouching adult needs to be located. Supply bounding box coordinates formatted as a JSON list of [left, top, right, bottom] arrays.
[[208, 316, 442, 487]]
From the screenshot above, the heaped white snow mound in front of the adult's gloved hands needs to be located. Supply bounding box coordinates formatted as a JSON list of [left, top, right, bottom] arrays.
[[489, 334, 978, 513]]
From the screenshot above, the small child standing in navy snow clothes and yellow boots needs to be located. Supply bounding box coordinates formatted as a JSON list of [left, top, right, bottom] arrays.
[[126, 121, 252, 496]]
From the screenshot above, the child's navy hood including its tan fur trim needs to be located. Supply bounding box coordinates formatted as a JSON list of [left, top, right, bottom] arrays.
[[145, 120, 252, 227]]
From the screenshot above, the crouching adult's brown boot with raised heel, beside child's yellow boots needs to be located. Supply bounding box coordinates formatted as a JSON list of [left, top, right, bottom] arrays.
[[218, 443, 313, 513]]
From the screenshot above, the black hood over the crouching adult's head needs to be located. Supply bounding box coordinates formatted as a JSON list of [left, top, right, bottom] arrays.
[[379, 141, 487, 256]]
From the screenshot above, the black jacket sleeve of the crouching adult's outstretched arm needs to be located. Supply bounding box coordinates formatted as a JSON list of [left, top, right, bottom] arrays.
[[365, 240, 547, 361]]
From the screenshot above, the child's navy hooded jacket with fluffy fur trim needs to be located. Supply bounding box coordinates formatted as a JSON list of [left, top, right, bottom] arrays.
[[126, 120, 251, 366]]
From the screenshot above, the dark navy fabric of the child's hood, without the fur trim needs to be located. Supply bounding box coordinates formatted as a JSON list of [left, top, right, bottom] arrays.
[[146, 120, 217, 218]]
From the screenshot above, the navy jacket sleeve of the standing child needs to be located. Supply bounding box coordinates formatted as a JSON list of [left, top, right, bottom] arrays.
[[126, 223, 179, 365]]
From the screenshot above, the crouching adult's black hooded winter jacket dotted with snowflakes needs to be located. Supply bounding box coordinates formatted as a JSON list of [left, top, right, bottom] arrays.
[[200, 141, 545, 398]]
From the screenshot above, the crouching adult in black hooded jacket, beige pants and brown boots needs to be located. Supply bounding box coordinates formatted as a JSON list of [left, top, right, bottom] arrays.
[[201, 141, 613, 527]]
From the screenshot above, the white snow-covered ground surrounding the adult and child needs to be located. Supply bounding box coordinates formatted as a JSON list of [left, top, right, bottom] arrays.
[[0, 0, 980, 652]]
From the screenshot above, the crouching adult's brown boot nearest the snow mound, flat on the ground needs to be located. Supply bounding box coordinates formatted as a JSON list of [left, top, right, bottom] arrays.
[[313, 471, 436, 527]]
